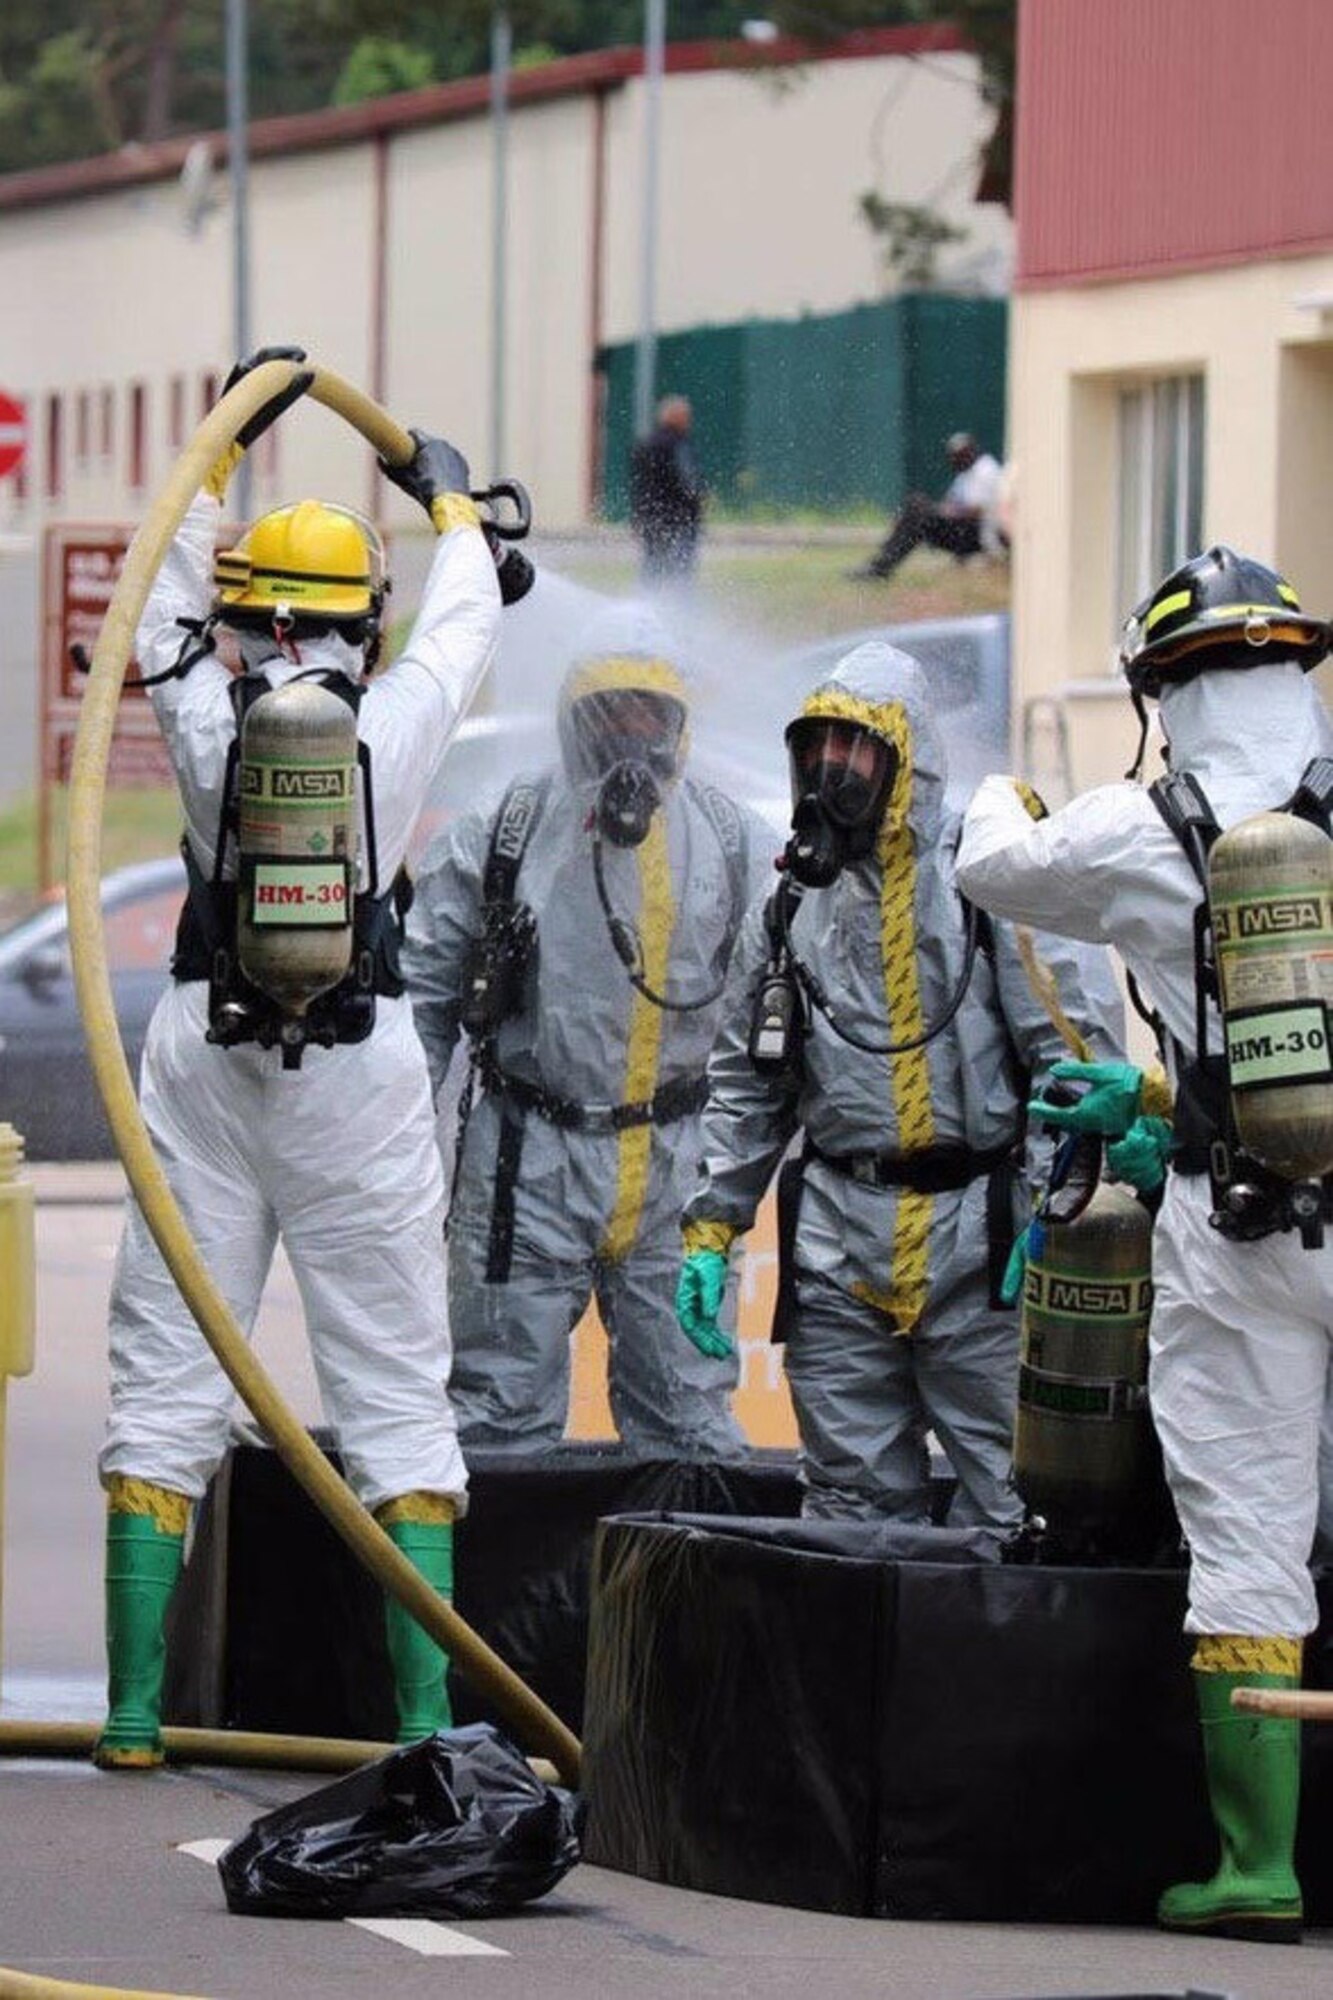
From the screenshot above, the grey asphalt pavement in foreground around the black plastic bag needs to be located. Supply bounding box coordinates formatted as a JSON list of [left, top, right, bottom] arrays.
[[0, 1758, 1333, 2000]]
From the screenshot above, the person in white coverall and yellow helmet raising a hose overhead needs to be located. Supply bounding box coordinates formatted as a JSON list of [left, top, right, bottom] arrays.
[[94, 348, 500, 1768]]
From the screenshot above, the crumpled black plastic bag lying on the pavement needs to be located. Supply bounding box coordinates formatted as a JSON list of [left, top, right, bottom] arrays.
[[218, 1722, 580, 1916]]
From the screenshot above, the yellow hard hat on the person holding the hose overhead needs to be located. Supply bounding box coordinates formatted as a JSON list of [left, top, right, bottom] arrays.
[[212, 500, 384, 620]]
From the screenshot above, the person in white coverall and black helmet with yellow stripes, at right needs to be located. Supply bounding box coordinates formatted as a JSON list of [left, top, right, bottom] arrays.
[[959, 546, 1333, 1944]]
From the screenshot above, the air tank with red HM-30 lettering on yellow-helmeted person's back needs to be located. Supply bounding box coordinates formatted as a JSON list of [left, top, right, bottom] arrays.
[[236, 680, 356, 1016]]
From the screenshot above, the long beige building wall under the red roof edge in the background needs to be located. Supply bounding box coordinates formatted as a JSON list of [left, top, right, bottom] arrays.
[[0, 54, 1009, 532]]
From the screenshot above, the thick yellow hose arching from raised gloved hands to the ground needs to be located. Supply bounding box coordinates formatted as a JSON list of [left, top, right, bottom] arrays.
[[66, 360, 580, 1786]]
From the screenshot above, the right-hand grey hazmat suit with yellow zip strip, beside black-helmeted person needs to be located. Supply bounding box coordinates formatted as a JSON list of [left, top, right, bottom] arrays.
[[685, 642, 1121, 1526]]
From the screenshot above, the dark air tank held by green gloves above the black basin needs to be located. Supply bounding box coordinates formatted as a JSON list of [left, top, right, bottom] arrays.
[[1013, 1182, 1163, 1556]]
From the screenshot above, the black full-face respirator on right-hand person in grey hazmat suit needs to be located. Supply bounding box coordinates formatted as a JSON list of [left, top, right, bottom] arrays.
[[783, 716, 899, 888]]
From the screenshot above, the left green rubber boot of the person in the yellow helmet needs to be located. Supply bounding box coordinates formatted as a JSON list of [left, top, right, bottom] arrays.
[[92, 1480, 190, 1770]]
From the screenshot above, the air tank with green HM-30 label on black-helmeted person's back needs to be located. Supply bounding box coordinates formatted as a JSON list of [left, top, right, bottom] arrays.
[[1209, 812, 1333, 1180]]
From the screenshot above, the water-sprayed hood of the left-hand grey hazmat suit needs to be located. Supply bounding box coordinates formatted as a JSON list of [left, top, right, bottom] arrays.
[[556, 602, 691, 790]]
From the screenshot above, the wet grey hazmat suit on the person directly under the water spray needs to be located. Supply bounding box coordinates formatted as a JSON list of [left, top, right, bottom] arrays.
[[404, 604, 779, 1456]]
